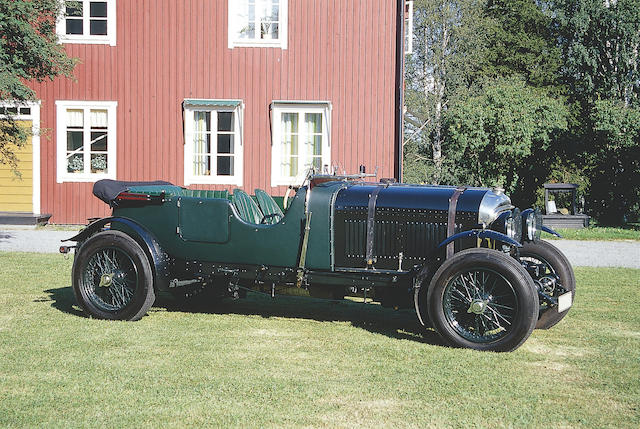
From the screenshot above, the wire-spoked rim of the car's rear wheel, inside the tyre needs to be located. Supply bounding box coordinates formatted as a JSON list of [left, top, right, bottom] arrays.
[[82, 247, 138, 311]]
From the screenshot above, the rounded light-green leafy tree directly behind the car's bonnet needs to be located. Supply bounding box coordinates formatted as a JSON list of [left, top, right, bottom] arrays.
[[444, 77, 567, 193]]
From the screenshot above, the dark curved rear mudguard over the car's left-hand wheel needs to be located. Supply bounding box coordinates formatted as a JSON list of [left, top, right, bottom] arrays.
[[62, 217, 169, 291]]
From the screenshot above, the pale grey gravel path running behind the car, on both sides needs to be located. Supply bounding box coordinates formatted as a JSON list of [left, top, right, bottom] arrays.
[[0, 226, 640, 269]]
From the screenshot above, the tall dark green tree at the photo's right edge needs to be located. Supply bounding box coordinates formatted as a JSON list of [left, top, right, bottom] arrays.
[[549, 0, 640, 224]]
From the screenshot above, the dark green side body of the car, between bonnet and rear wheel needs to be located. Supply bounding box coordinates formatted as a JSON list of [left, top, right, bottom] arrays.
[[113, 188, 310, 267]]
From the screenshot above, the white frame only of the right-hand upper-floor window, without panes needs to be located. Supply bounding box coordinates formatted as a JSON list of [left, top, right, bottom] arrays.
[[227, 0, 289, 49]]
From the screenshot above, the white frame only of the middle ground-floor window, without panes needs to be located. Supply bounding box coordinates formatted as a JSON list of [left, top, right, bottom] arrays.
[[184, 100, 244, 186]]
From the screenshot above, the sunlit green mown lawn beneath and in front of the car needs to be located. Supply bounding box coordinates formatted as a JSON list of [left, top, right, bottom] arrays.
[[0, 253, 640, 428]]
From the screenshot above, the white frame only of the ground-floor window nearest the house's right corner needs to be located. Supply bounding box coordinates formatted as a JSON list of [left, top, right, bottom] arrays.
[[271, 101, 332, 187]]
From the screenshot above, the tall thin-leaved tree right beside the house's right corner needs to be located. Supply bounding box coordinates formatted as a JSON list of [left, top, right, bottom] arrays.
[[405, 0, 487, 183]]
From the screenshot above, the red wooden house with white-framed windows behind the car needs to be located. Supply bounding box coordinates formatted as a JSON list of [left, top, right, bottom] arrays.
[[0, 0, 405, 223]]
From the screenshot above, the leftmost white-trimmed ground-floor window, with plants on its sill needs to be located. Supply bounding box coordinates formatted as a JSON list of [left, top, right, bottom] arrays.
[[56, 101, 117, 183]]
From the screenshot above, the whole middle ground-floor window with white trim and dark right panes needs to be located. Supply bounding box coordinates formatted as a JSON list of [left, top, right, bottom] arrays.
[[184, 100, 243, 186]]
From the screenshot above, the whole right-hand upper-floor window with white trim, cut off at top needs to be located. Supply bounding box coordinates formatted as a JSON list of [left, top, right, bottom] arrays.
[[229, 0, 288, 49]]
